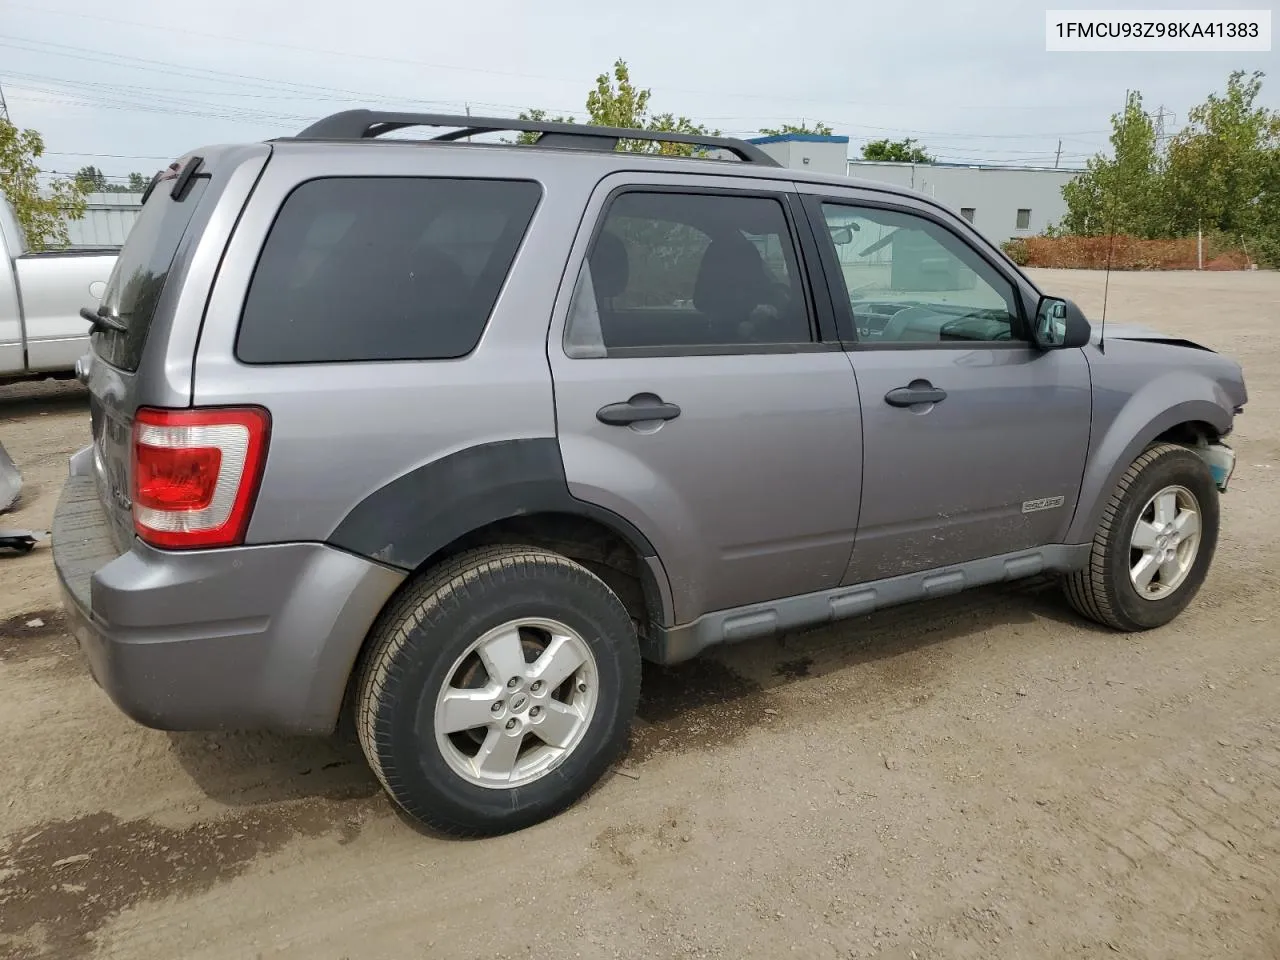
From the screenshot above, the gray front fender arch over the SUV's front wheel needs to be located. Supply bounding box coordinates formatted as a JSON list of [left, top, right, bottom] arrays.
[[1065, 370, 1234, 543]]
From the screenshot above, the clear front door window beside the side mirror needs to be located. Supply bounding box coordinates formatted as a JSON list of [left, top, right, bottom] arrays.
[[822, 204, 1020, 344]]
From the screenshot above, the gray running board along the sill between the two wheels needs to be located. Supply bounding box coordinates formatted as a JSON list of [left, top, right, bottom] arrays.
[[641, 544, 1092, 663]]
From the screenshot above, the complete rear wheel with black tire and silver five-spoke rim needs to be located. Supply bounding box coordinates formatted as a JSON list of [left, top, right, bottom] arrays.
[[357, 547, 640, 835]]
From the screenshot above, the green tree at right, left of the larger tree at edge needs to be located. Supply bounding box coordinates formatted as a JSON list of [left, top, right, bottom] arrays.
[[1062, 91, 1169, 237]]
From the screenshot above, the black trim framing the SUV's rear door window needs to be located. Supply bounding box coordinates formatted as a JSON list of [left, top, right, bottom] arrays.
[[559, 182, 844, 362]]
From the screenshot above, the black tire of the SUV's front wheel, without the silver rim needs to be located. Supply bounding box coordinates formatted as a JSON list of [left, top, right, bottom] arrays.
[[1064, 443, 1219, 632]]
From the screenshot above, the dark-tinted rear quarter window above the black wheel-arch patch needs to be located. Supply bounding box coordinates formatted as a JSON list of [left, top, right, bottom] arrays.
[[236, 177, 541, 364]]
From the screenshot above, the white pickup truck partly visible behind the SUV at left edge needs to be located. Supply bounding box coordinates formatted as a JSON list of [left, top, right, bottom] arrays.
[[0, 195, 119, 383]]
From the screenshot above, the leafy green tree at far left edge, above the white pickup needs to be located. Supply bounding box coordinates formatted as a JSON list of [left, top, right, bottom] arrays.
[[0, 119, 84, 250]]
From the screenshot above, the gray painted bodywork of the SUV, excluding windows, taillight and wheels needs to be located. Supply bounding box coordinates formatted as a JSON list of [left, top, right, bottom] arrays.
[[55, 131, 1244, 731]]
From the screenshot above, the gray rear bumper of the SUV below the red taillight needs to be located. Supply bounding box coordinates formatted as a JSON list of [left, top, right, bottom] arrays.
[[52, 476, 404, 735]]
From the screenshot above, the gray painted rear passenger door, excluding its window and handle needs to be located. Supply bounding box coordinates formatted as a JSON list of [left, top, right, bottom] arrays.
[[549, 172, 861, 622]]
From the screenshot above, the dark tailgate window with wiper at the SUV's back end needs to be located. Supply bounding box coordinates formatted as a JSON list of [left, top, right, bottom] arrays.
[[93, 177, 209, 372]]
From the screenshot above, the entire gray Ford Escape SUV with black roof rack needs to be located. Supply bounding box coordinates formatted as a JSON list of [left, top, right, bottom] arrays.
[[54, 110, 1245, 835]]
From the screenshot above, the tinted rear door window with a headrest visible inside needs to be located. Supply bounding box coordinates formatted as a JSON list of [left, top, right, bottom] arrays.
[[564, 192, 813, 357]]
